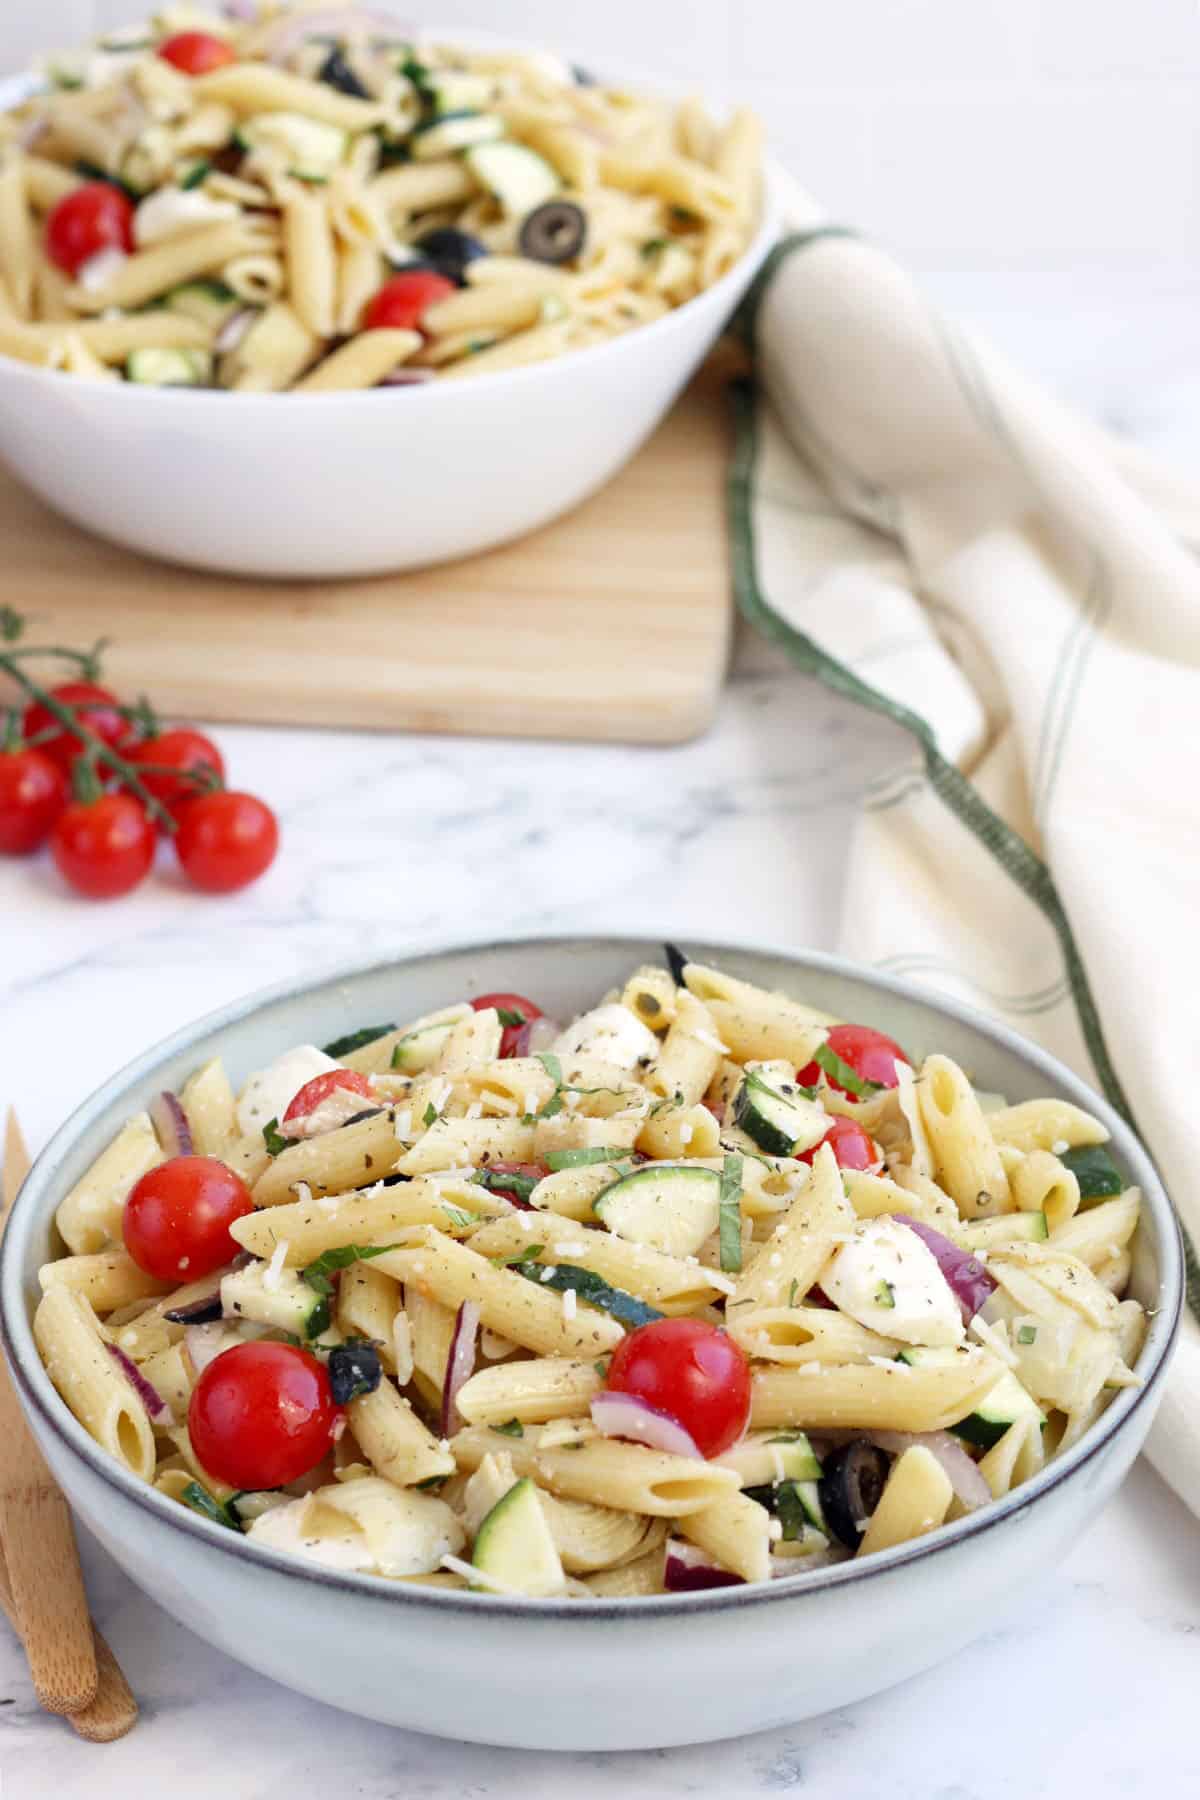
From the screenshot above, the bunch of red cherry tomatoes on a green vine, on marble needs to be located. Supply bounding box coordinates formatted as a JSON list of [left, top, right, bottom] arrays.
[[0, 608, 279, 900]]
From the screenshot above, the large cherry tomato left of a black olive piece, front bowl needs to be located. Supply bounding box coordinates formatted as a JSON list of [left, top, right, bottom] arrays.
[[187, 1341, 338, 1490]]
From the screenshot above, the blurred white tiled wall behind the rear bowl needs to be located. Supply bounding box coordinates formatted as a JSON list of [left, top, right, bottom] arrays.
[[9, 0, 1200, 274]]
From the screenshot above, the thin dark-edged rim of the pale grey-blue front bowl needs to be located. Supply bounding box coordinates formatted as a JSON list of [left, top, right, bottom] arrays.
[[0, 932, 1184, 1622]]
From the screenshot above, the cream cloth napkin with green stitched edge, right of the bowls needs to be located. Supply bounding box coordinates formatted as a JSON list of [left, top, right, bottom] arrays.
[[730, 191, 1200, 1514]]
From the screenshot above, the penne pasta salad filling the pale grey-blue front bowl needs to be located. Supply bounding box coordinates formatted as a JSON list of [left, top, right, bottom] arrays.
[[34, 950, 1146, 1600]]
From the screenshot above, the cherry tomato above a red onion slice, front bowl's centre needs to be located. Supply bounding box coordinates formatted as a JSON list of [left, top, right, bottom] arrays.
[[608, 1319, 750, 1456]]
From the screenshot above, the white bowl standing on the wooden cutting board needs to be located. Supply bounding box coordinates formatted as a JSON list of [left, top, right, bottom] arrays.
[[0, 131, 775, 580]]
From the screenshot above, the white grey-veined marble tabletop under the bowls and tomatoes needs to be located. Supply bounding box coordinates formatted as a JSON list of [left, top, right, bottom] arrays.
[[0, 272, 1200, 1800]]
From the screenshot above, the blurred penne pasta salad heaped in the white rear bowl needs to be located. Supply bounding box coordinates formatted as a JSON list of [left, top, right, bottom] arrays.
[[0, 0, 761, 392]]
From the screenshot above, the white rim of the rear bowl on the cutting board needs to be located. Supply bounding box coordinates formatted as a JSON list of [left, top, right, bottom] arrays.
[[0, 39, 788, 416]]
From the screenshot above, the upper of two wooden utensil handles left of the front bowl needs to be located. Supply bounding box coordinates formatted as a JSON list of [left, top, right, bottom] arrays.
[[0, 1112, 99, 1712]]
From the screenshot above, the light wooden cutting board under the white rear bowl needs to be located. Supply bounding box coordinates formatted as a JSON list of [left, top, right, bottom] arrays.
[[0, 364, 732, 743]]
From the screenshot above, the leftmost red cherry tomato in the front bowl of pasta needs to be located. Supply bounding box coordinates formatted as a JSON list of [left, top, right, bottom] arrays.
[[121, 1156, 254, 1282]]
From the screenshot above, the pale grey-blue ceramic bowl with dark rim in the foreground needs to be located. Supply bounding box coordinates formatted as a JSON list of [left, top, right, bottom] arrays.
[[0, 938, 1182, 1750]]
